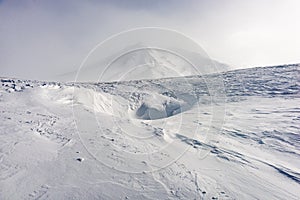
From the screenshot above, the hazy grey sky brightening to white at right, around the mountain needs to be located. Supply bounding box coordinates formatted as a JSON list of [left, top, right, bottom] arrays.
[[0, 0, 300, 79]]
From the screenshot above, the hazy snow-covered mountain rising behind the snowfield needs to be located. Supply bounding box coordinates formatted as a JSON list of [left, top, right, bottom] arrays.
[[60, 44, 229, 82]]
